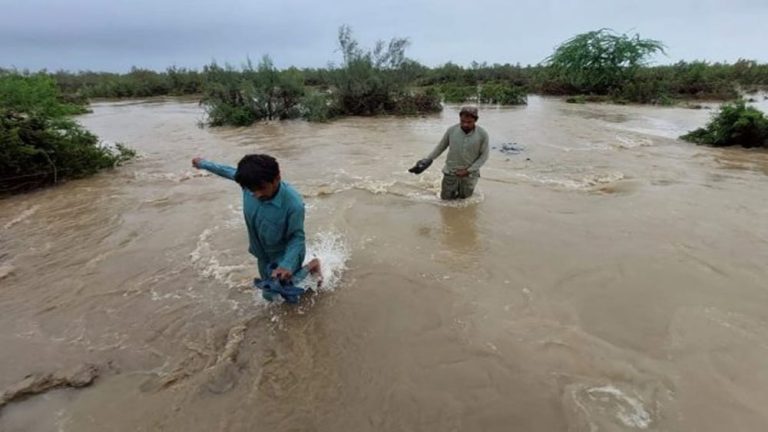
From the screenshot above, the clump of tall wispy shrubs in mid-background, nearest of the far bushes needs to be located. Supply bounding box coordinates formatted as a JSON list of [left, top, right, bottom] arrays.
[[201, 26, 442, 126]]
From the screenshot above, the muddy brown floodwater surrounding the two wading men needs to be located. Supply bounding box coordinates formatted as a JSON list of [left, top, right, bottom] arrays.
[[0, 97, 768, 432]]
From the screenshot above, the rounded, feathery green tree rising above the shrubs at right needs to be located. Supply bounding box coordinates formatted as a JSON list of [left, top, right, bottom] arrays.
[[544, 29, 664, 94]]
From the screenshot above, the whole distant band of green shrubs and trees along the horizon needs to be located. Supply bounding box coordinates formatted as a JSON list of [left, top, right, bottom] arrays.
[[16, 26, 768, 122]]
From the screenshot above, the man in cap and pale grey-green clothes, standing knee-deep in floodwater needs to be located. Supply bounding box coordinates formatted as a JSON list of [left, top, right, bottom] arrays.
[[408, 106, 489, 200]]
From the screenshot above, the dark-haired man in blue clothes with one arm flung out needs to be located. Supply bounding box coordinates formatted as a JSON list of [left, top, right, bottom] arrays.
[[192, 154, 320, 292]]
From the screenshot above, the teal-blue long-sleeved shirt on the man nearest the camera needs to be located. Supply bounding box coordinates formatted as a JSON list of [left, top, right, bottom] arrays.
[[199, 160, 306, 278]]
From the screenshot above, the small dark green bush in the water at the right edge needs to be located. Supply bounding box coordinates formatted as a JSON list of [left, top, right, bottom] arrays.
[[680, 100, 768, 148]]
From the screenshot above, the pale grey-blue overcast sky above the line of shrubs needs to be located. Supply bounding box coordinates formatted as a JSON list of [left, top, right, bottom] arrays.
[[0, 0, 768, 72]]
